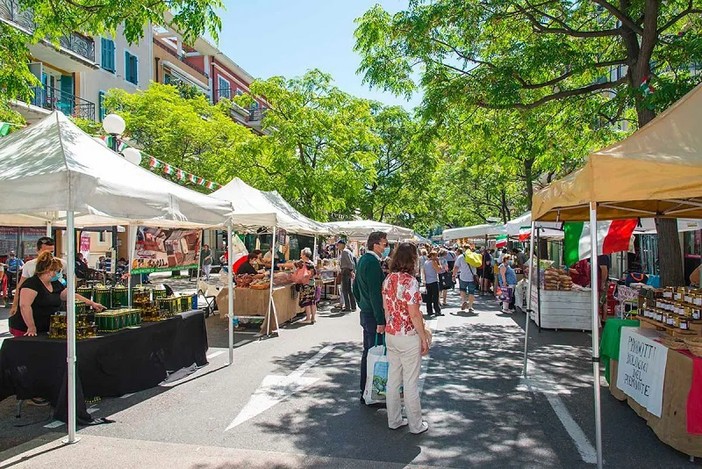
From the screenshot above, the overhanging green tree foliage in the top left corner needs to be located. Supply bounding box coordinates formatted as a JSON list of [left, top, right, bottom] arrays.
[[0, 0, 223, 110]]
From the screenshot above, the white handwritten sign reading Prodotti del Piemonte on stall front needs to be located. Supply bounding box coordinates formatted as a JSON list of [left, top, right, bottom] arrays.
[[617, 327, 668, 417]]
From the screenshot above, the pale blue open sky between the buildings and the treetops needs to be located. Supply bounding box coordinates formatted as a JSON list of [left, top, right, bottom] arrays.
[[219, 0, 420, 110]]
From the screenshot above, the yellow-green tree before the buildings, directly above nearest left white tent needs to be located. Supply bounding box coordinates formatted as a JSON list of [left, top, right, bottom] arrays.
[[99, 83, 254, 188]]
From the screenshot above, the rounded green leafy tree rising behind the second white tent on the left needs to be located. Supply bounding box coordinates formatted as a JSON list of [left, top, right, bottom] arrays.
[[243, 70, 378, 219]]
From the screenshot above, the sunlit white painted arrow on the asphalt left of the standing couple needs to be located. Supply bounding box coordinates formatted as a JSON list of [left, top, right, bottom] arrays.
[[224, 345, 334, 432]]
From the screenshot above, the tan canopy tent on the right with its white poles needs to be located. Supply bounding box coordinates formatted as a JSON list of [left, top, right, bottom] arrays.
[[524, 85, 702, 467]]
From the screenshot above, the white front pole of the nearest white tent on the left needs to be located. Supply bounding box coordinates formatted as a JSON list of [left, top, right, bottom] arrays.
[[64, 210, 78, 444]]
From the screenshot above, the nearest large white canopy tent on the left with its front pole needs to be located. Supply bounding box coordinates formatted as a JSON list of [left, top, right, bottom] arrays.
[[0, 111, 232, 443]]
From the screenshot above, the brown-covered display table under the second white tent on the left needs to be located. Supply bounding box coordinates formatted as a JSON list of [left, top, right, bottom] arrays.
[[217, 285, 300, 332]]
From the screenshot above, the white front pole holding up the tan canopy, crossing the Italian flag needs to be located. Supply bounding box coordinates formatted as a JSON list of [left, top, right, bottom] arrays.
[[590, 202, 602, 469]]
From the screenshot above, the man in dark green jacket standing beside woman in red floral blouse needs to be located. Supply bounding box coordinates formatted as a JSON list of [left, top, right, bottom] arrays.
[[353, 231, 388, 401]]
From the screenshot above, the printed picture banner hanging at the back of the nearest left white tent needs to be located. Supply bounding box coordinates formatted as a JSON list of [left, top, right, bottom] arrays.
[[132, 226, 202, 274]]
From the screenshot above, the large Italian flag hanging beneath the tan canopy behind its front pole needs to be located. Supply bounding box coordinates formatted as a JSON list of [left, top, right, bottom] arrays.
[[563, 219, 638, 265]]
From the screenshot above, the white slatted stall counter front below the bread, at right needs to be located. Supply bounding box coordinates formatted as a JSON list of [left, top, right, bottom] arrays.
[[530, 288, 592, 331]]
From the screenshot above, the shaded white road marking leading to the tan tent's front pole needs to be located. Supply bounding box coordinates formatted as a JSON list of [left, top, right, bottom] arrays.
[[517, 362, 597, 464]]
